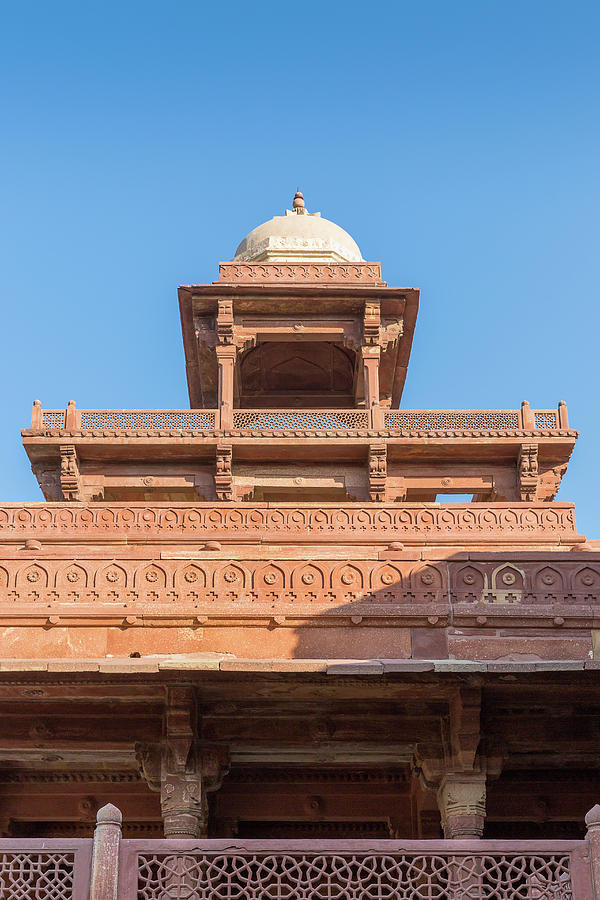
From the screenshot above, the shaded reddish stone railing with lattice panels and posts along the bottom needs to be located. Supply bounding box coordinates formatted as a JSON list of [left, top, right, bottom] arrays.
[[0, 804, 600, 900]]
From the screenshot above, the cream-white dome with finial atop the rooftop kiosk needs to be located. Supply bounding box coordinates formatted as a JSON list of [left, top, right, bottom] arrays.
[[233, 191, 362, 262]]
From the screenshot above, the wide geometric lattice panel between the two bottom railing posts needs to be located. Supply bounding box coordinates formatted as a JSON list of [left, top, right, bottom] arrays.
[[138, 849, 571, 900]]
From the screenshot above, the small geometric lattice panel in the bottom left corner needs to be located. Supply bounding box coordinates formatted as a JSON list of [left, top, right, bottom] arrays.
[[0, 852, 75, 900]]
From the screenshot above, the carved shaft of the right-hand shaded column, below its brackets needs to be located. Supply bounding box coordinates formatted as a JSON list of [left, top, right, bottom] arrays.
[[437, 773, 486, 839]]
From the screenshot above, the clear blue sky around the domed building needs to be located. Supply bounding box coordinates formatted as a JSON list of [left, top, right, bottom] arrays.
[[0, 0, 600, 536]]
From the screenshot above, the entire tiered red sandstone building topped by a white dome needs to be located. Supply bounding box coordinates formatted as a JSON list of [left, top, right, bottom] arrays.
[[0, 193, 600, 900]]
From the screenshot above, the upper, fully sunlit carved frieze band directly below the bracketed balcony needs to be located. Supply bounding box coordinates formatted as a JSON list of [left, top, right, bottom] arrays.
[[0, 503, 582, 545]]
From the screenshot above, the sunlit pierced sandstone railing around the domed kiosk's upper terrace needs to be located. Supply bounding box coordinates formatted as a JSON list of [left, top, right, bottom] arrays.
[[31, 401, 569, 436]]
